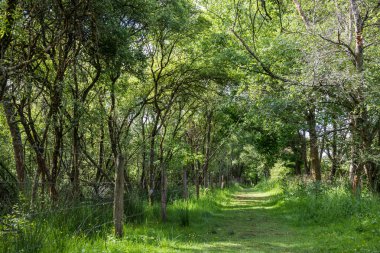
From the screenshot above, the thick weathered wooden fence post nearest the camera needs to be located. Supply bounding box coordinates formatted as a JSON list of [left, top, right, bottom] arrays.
[[113, 154, 125, 238]]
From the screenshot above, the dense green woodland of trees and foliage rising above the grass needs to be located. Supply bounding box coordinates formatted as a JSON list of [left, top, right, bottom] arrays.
[[0, 0, 380, 251]]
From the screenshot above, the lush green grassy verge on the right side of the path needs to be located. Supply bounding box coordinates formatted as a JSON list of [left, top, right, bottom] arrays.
[[255, 177, 380, 252]]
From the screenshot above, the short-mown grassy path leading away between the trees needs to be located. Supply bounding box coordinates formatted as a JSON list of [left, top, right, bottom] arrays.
[[174, 189, 308, 252]]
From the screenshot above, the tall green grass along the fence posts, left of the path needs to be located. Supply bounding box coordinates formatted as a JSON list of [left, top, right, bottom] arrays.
[[0, 187, 228, 253]]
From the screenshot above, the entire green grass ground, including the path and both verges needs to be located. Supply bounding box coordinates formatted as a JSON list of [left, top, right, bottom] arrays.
[[0, 182, 380, 252]]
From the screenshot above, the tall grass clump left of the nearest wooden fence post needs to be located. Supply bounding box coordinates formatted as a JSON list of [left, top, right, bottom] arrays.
[[0, 198, 112, 253]]
